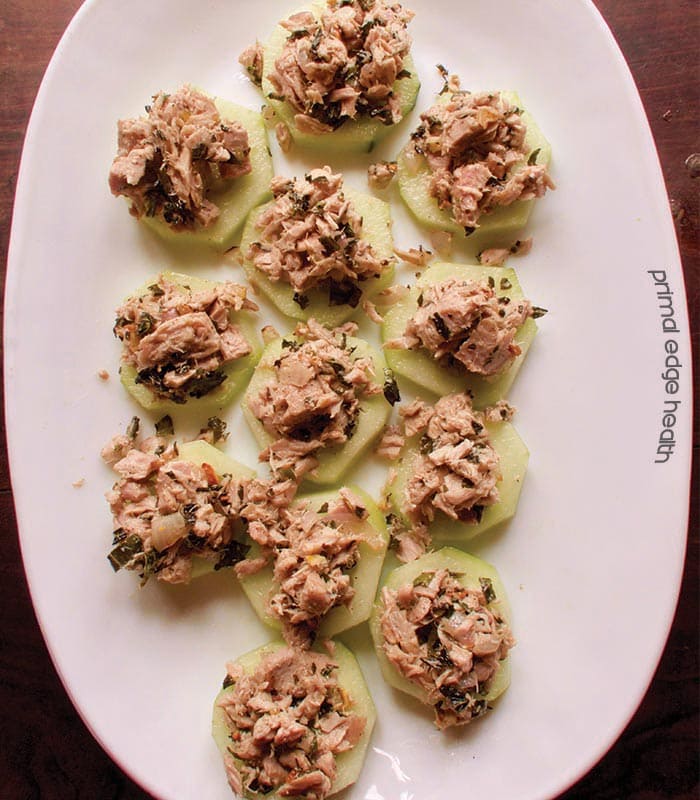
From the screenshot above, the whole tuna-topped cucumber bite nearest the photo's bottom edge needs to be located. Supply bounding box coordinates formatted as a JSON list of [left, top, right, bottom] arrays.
[[212, 642, 376, 800]]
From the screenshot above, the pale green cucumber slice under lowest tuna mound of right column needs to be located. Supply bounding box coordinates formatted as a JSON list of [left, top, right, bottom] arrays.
[[369, 547, 510, 704]]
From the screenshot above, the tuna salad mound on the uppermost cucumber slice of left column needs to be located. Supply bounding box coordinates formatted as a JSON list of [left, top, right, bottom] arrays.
[[109, 86, 251, 230]]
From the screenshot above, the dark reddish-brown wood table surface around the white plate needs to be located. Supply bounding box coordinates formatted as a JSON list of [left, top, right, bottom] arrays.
[[0, 0, 700, 800]]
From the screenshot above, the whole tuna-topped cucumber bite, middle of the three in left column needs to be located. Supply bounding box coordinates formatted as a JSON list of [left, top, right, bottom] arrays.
[[114, 272, 260, 413]]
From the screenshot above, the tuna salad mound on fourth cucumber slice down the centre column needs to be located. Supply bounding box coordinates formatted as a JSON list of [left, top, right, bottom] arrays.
[[236, 489, 369, 647]]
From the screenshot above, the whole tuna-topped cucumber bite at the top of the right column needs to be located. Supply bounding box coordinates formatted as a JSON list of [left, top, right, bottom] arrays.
[[398, 81, 554, 247]]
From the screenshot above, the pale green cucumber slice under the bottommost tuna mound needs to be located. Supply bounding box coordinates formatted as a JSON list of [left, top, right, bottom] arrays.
[[212, 642, 377, 800]]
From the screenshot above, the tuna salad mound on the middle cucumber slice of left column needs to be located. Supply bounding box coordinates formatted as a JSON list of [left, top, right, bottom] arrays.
[[114, 275, 258, 403]]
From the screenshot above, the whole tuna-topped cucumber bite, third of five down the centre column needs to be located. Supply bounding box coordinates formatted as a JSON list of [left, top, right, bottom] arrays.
[[243, 319, 394, 484]]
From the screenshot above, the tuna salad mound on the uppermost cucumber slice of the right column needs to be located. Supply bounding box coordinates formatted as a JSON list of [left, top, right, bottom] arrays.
[[406, 87, 554, 234]]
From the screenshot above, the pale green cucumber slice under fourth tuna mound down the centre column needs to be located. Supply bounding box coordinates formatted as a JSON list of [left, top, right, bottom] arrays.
[[241, 486, 389, 638]]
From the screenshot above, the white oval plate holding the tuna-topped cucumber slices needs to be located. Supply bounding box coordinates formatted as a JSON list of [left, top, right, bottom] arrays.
[[5, 0, 691, 800]]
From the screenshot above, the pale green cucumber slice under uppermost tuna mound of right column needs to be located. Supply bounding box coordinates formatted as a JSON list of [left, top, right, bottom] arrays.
[[397, 92, 552, 249]]
